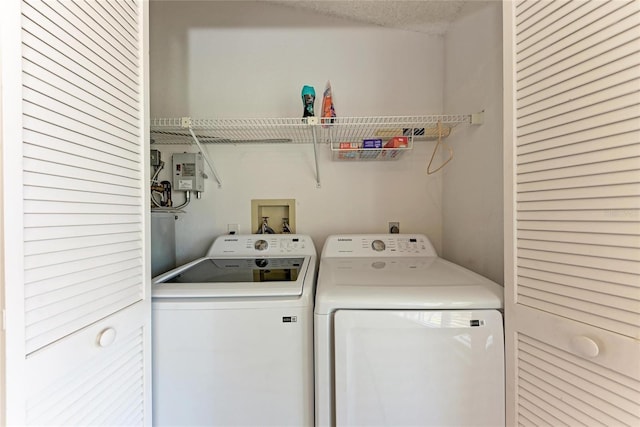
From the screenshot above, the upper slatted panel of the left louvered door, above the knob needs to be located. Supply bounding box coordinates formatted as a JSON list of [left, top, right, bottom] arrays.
[[22, 0, 144, 353]]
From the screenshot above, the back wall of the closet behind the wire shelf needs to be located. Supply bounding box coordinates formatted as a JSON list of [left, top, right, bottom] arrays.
[[150, 1, 448, 264]]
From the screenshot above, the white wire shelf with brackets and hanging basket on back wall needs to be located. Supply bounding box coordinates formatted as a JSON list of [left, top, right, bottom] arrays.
[[150, 113, 482, 187]]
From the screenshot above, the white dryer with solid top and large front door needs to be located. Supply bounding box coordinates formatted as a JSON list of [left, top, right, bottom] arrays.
[[314, 234, 505, 427]]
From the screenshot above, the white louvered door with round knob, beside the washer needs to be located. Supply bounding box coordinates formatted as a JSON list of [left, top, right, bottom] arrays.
[[3, 0, 151, 425]]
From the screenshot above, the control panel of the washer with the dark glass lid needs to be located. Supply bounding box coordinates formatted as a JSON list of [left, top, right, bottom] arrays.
[[207, 234, 316, 256]]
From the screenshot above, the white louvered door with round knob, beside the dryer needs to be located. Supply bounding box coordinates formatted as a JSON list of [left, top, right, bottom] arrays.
[[503, 0, 640, 426]]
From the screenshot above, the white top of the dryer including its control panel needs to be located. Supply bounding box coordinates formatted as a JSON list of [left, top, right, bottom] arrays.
[[315, 235, 503, 314]]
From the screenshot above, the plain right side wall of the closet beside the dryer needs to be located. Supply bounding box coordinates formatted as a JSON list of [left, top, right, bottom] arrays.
[[442, 1, 503, 283]]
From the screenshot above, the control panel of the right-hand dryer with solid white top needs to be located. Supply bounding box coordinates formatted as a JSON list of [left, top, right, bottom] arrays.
[[322, 234, 437, 258]]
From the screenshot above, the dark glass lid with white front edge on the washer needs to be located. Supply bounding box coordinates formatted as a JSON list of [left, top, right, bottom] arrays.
[[153, 257, 311, 298]]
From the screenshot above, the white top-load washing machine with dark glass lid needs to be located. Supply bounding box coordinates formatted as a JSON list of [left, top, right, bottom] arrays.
[[152, 234, 317, 426]]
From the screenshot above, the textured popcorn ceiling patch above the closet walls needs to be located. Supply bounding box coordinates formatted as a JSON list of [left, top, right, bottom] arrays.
[[273, 0, 496, 34]]
